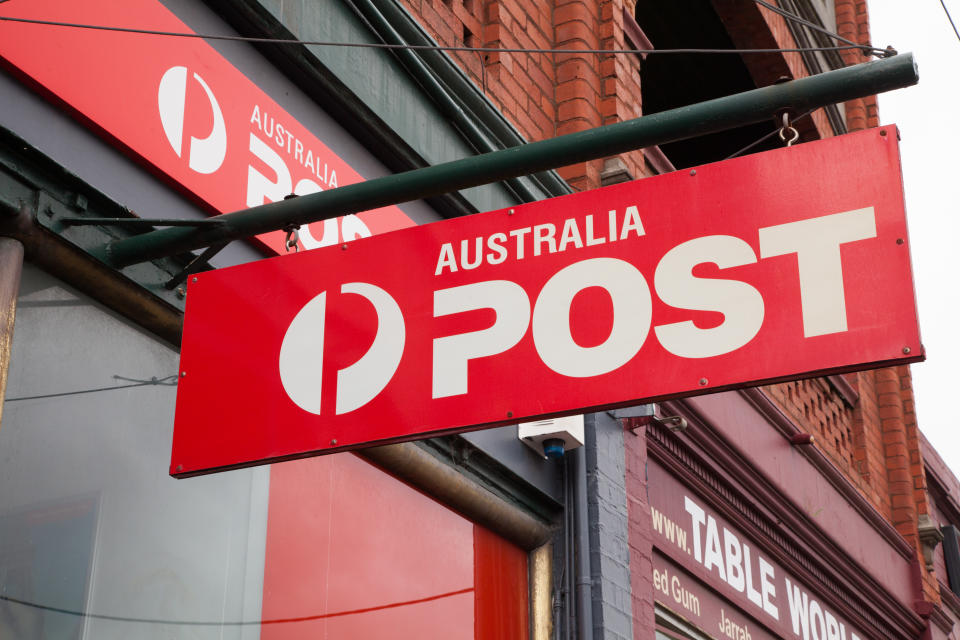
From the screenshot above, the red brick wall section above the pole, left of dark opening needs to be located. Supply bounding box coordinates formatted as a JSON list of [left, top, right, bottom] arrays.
[[401, 0, 645, 190]]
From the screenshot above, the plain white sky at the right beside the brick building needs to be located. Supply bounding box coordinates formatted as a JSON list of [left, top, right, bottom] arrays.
[[868, 0, 960, 475]]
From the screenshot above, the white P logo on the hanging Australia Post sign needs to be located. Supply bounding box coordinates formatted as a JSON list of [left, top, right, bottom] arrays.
[[280, 282, 407, 415]]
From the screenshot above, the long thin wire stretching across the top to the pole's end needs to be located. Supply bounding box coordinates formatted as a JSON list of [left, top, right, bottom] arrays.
[[0, 16, 888, 55]]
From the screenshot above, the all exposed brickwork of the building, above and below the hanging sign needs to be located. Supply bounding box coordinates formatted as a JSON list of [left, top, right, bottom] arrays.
[[401, 0, 939, 624]]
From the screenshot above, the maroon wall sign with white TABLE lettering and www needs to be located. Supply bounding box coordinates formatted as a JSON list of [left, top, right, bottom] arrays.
[[647, 463, 867, 640]]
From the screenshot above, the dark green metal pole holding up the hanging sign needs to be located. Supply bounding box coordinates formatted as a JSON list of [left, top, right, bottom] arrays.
[[102, 53, 919, 267]]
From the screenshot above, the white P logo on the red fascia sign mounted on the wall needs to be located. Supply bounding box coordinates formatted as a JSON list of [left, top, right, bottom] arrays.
[[157, 67, 227, 173]]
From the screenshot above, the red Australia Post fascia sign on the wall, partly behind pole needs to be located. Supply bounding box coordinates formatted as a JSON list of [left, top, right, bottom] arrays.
[[0, 0, 413, 253]]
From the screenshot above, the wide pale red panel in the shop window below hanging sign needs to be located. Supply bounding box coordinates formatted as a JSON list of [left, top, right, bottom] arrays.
[[261, 455, 474, 640]]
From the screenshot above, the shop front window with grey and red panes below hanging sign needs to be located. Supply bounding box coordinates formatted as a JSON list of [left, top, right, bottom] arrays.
[[0, 264, 528, 640]]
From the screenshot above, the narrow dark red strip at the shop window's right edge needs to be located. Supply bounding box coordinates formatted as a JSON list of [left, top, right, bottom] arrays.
[[473, 526, 530, 640]]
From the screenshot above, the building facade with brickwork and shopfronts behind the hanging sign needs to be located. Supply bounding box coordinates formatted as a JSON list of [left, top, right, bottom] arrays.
[[0, 0, 944, 640]]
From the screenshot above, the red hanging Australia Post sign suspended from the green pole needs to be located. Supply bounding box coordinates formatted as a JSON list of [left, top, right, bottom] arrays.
[[170, 127, 923, 476]]
